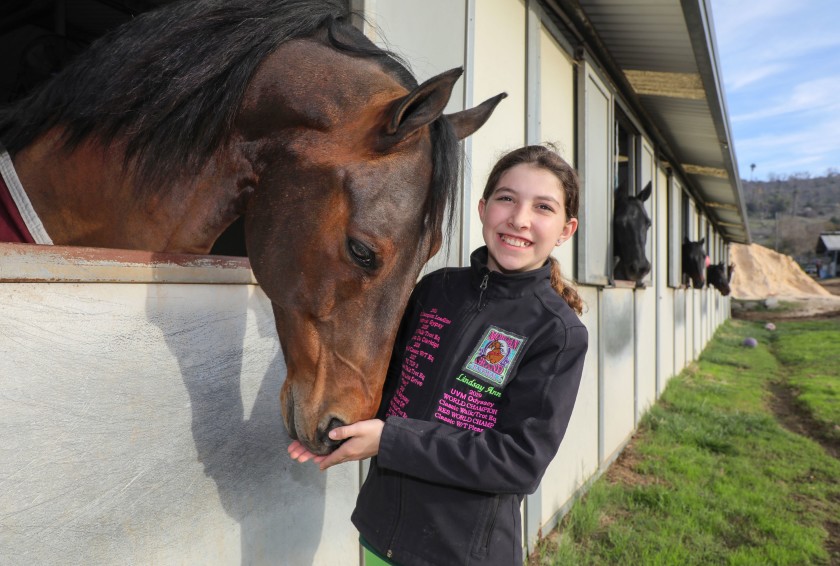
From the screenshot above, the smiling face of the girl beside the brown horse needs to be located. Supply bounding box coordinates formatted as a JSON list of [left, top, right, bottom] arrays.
[[478, 164, 578, 273]]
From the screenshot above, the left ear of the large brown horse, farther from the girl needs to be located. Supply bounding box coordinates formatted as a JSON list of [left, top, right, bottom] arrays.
[[384, 67, 464, 147]]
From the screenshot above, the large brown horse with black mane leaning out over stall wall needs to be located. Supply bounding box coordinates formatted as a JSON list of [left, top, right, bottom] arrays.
[[0, 0, 504, 454]]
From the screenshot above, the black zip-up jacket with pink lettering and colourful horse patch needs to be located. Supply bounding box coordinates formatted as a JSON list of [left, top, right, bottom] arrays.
[[352, 248, 588, 566]]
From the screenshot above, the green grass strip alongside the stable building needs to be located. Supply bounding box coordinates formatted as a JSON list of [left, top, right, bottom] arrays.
[[531, 321, 840, 565]]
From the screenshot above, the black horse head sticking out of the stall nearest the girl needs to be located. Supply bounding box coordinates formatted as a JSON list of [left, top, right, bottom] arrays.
[[613, 182, 652, 281]]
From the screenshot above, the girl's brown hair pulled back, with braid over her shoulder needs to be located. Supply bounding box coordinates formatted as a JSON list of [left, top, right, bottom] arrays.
[[481, 144, 583, 314]]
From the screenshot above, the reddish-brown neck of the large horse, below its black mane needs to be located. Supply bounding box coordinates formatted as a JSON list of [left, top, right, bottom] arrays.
[[14, 132, 243, 253]]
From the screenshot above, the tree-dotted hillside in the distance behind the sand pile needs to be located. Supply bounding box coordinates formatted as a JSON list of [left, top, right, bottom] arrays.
[[741, 170, 840, 265]]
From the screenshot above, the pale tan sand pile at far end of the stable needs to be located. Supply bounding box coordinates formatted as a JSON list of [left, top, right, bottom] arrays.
[[729, 244, 831, 300]]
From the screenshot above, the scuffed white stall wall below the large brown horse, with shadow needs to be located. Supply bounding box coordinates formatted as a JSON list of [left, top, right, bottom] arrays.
[[0, 244, 359, 566]]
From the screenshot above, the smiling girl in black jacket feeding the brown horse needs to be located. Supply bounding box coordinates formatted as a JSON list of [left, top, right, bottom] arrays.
[[289, 146, 587, 566]]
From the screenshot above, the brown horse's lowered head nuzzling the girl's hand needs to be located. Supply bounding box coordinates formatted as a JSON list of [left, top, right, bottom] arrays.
[[238, 35, 503, 454]]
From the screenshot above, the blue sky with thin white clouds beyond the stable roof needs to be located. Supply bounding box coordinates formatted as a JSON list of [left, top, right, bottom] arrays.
[[711, 0, 840, 181]]
